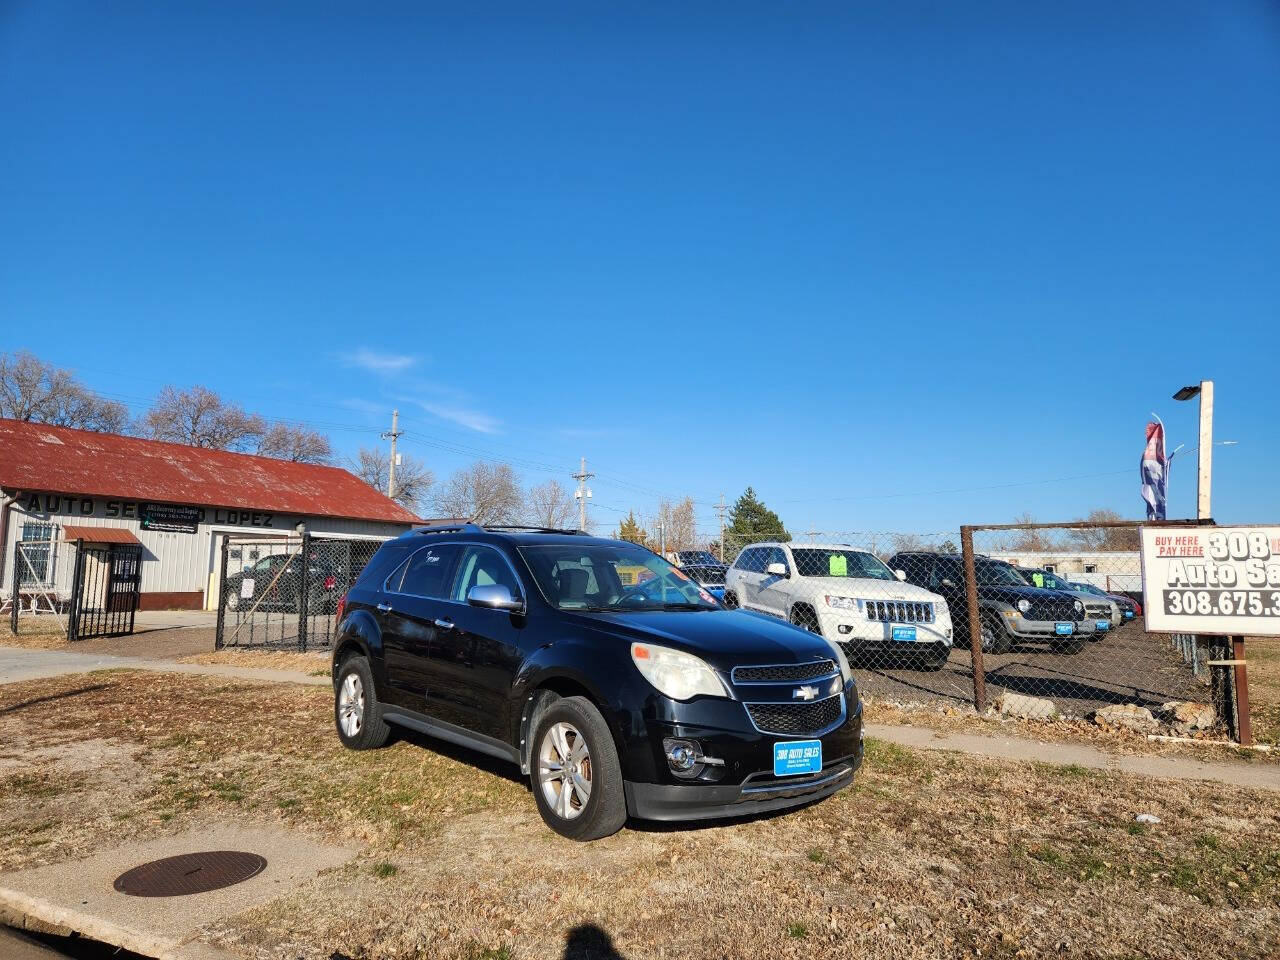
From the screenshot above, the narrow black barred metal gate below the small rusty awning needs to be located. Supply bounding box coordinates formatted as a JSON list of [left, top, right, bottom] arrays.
[[67, 543, 142, 640]]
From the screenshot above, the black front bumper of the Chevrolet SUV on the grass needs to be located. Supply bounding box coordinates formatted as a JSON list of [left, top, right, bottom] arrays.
[[623, 684, 863, 820]]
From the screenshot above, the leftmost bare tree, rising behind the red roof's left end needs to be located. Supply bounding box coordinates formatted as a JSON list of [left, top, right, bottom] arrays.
[[0, 351, 129, 433]]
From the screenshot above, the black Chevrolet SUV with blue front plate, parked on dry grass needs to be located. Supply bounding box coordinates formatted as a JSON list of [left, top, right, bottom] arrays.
[[333, 524, 863, 840]]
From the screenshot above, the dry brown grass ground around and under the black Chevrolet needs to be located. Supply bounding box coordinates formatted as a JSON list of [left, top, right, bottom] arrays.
[[0, 672, 1280, 960]]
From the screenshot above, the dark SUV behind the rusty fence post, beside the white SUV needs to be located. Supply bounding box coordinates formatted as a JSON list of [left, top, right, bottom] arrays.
[[888, 552, 1093, 653]]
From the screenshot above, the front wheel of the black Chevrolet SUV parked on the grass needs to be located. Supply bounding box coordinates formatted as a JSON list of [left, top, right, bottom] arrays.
[[529, 696, 627, 841]]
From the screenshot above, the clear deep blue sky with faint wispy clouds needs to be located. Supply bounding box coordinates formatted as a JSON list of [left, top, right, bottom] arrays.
[[0, 0, 1280, 531]]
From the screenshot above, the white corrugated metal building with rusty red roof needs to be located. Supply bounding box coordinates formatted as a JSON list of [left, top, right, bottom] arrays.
[[0, 419, 420, 609]]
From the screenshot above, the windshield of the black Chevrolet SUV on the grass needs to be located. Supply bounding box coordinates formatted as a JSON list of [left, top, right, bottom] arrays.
[[520, 541, 719, 612]]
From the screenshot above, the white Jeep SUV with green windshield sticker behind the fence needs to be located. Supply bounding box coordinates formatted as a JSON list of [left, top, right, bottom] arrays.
[[724, 543, 951, 669]]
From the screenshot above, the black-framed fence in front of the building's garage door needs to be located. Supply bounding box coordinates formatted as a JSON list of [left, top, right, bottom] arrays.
[[215, 534, 383, 650]]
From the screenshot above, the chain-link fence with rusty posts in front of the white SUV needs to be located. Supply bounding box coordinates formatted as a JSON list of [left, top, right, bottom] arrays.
[[724, 522, 1254, 736]]
